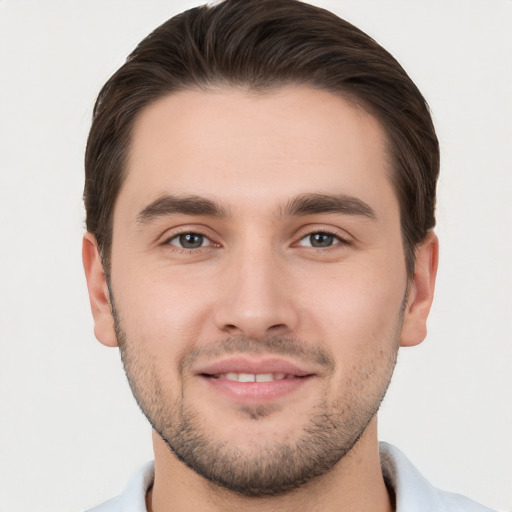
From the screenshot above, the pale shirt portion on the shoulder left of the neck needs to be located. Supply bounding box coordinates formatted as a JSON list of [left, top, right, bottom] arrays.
[[82, 462, 155, 512]]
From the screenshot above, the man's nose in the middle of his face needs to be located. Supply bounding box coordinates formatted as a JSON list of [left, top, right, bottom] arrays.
[[215, 244, 299, 339]]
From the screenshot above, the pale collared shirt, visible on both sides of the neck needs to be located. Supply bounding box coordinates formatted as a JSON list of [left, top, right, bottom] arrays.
[[88, 443, 496, 512]]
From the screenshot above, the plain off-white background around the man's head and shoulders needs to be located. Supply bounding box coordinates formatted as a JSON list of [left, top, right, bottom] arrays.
[[0, 0, 512, 512]]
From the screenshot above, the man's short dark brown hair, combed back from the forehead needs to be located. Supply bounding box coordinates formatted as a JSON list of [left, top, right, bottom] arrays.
[[84, 0, 439, 276]]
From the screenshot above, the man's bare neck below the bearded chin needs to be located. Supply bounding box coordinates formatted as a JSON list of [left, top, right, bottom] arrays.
[[146, 418, 393, 512]]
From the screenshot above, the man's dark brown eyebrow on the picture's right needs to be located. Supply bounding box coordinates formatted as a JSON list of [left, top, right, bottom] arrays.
[[282, 194, 377, 220]]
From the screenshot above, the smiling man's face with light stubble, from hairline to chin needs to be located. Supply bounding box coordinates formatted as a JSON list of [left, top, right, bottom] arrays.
[[84, 87, 436, 496]]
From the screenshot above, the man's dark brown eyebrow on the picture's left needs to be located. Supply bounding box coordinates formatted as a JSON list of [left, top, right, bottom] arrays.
[[137, 195, 227, 224]]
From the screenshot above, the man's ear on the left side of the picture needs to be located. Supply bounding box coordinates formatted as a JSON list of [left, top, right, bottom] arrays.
[[82, 232, 117, 347]]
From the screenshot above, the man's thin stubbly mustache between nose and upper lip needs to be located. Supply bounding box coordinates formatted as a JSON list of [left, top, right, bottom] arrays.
[[179, 336, 336, 373]]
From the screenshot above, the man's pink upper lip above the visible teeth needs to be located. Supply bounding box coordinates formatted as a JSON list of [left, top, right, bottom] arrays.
[[195, 356, 314, 377]]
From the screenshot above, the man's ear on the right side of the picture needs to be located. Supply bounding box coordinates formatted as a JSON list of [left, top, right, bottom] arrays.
[[400, 231, 439, 347]]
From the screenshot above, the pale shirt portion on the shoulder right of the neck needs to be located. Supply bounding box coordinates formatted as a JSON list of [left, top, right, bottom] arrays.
[[379, 443, 496, 512]]
